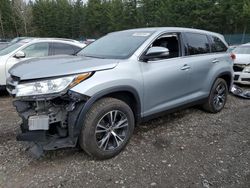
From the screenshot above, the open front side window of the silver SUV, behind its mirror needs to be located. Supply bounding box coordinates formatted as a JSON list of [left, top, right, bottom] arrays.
[[151, 34, 180, 59]]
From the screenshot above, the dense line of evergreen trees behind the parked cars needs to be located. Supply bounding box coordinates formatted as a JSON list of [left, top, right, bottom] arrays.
[[0, 0, 250, 39]]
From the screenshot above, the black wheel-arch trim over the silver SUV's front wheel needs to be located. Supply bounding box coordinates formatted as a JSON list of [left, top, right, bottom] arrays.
[[74, 86, 141, 137]]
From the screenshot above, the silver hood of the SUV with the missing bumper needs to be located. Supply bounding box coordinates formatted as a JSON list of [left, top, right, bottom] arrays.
[[9, 55, 118, 80]]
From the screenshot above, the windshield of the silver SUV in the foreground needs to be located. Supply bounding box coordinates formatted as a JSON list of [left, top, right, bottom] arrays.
[[77, 31, 152, 59]]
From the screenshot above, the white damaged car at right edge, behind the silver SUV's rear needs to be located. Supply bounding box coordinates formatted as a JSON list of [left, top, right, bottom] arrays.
[[232, 43, 250, 85]]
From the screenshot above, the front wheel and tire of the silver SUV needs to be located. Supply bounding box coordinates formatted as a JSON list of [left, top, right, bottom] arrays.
[[79, 98, 135, 160]]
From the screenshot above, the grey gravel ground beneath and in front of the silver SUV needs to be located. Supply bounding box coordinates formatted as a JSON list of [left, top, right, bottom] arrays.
[[0, 90, 250, 188]]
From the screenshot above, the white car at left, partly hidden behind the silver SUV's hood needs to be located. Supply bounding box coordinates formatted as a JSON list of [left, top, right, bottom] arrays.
[[0, 38, 86, 88]]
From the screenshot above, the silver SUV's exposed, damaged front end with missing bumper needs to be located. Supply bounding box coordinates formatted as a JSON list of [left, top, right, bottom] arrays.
[[7, 76, 89, 157]]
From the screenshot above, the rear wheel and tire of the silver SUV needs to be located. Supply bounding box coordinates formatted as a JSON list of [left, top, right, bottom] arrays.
[[202, 78, 228, 113]]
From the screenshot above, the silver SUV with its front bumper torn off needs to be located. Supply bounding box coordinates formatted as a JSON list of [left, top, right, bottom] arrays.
[[7, 27, 233, 159]]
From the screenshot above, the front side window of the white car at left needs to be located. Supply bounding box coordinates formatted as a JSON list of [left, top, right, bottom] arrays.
[[22, 42, 49, 57]]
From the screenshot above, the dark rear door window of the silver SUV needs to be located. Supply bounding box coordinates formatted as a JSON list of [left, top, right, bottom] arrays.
[[185, 33, 210, 55]]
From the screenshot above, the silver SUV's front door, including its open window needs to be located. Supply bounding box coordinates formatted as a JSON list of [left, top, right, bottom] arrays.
[[141, 33, 190, 116]]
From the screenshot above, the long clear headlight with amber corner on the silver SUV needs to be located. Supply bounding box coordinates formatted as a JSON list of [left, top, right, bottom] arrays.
[[16, 73, 91, 97]]
